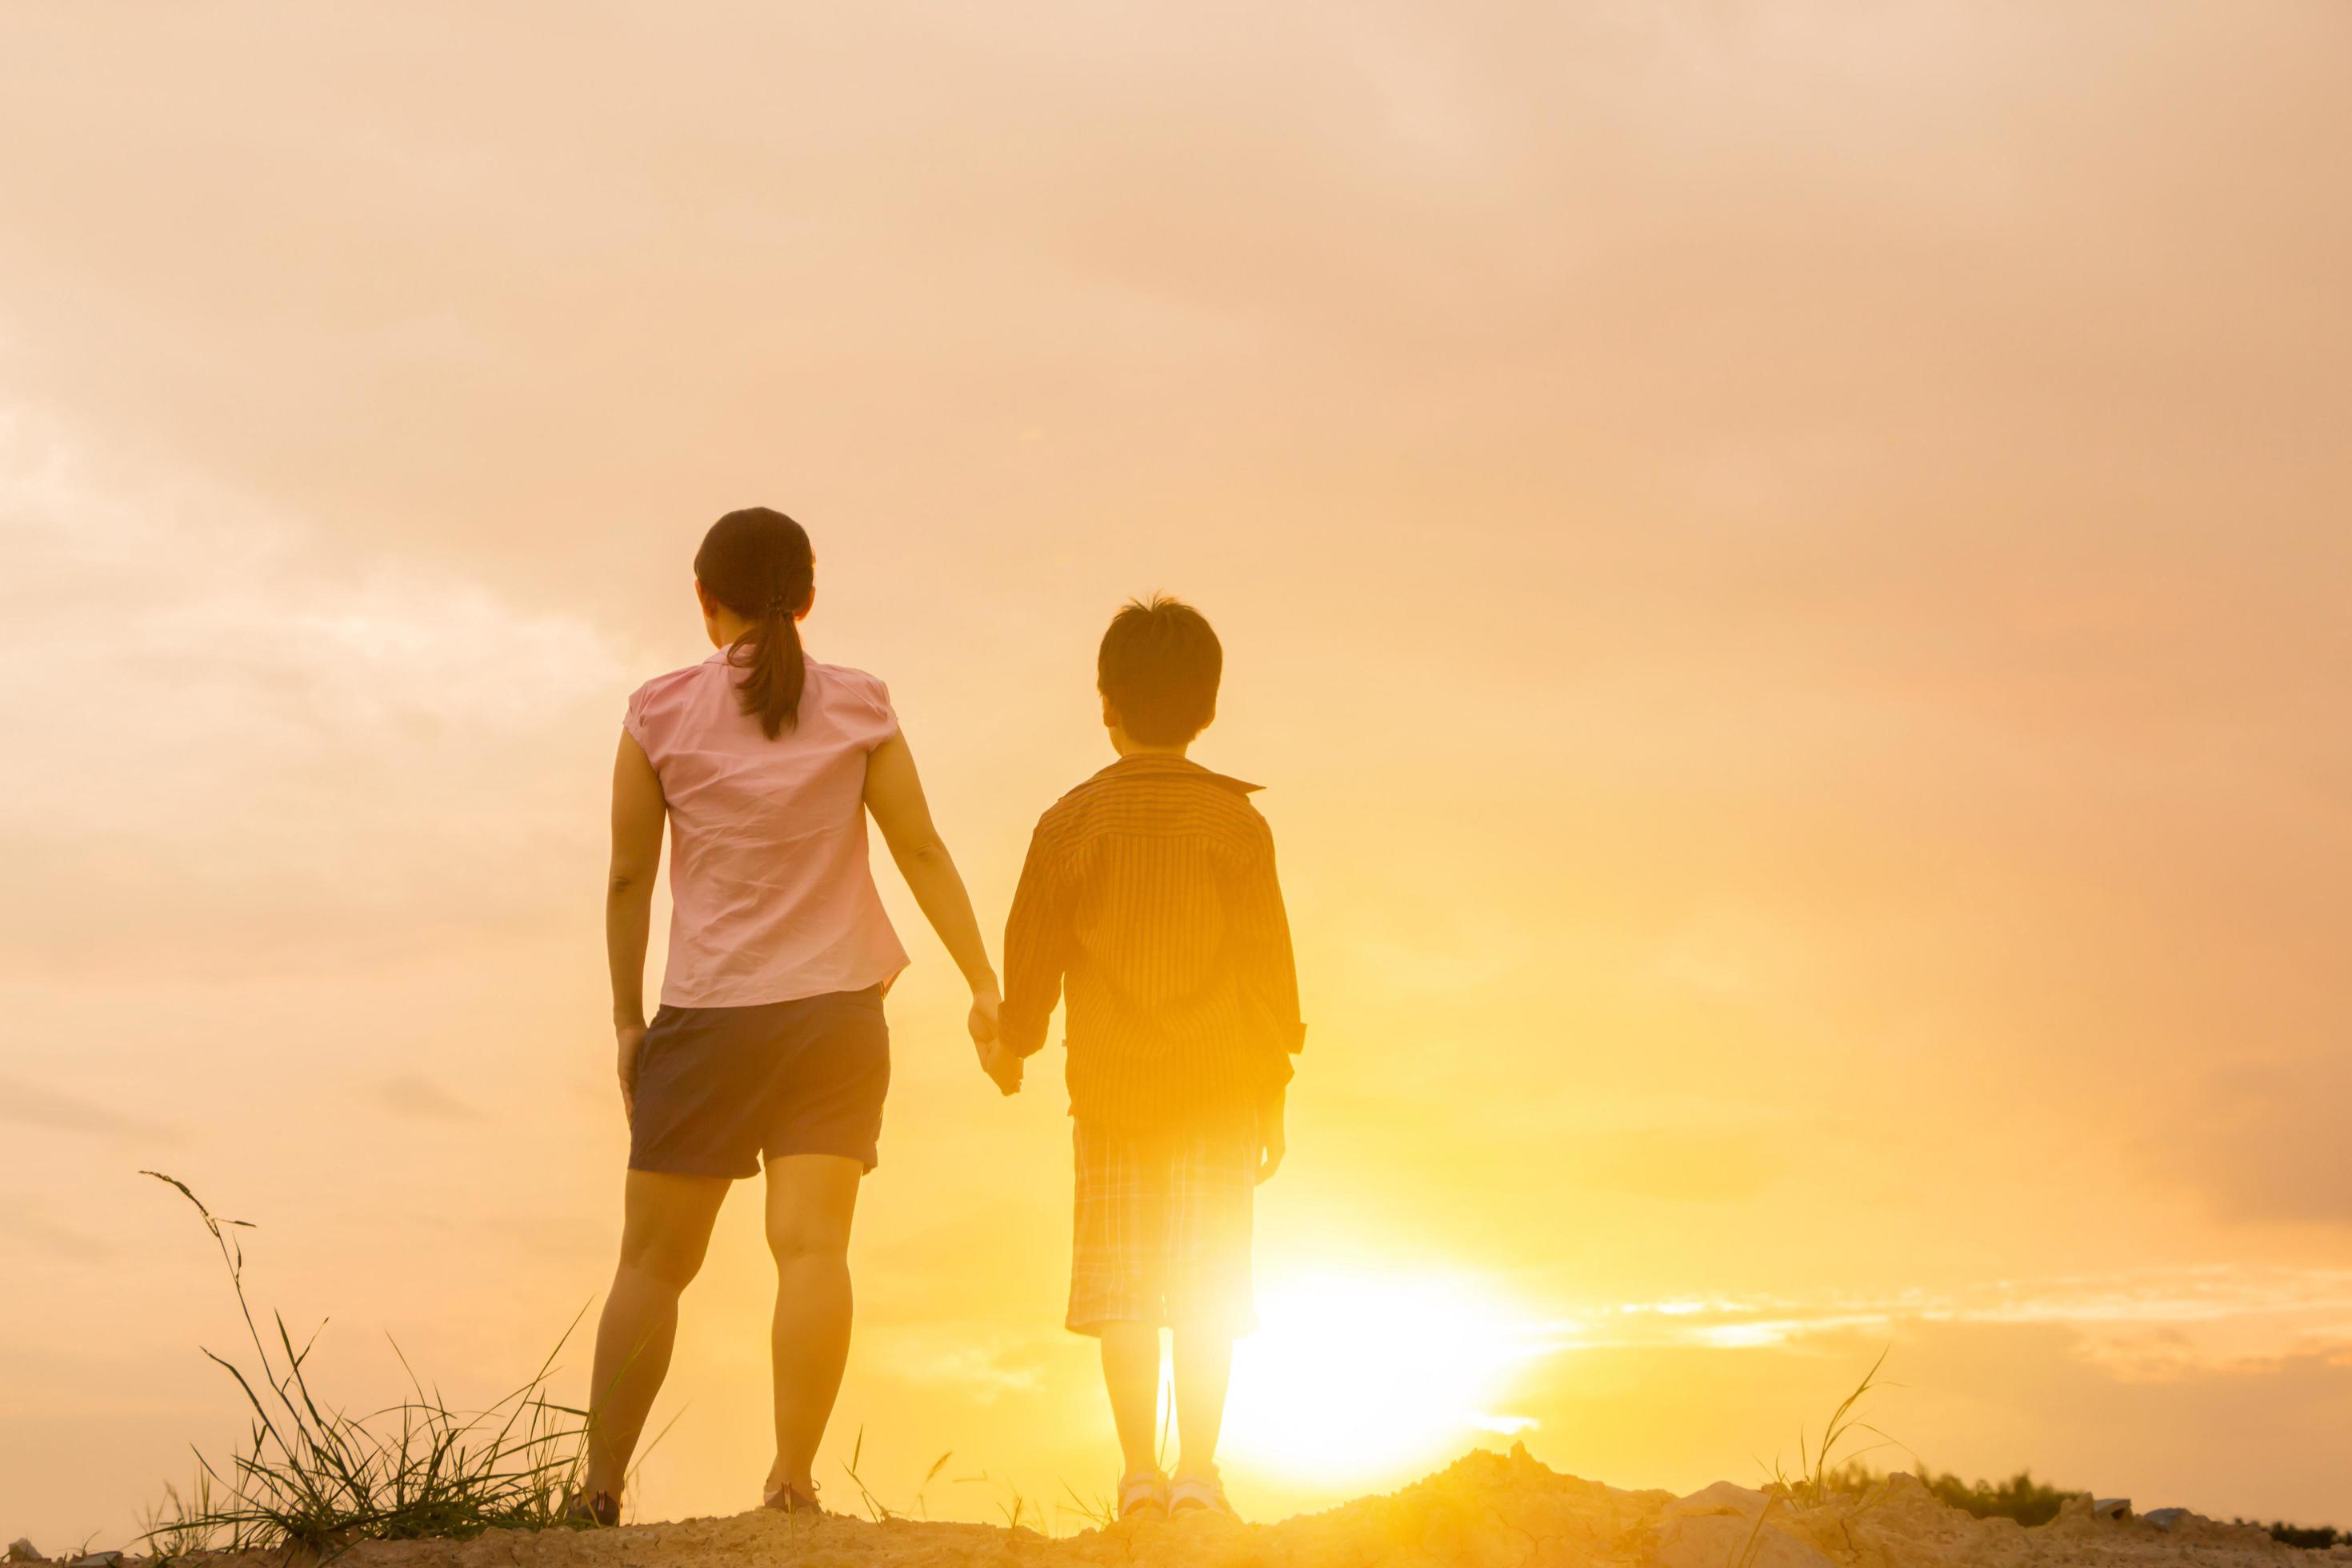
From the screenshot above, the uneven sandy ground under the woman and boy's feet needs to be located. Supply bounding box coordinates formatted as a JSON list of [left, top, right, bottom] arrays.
[[36, 1448, 2352, 1568]]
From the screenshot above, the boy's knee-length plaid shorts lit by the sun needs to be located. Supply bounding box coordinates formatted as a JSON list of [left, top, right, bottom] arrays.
[[1068, 1122, 1258, 1335]]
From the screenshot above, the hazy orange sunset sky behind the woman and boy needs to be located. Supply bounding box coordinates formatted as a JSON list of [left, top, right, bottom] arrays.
[[0, 0, 2352, 1549]]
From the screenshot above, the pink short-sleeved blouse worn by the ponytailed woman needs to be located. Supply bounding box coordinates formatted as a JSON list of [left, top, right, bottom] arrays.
[[623, 649, 906, 1006]]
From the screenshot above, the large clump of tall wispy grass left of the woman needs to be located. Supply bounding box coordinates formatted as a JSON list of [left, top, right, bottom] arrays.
[[141, 1170, 606, 1558]]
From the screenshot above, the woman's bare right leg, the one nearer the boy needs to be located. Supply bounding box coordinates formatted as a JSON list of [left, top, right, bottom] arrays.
[[766, 1154, 866, 1498]]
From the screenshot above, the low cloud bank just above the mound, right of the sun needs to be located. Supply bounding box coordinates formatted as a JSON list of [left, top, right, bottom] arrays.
[[1510, 1321, 2352, 1523]]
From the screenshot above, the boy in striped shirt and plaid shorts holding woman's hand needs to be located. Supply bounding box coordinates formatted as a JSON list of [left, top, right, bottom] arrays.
[[990, 597, 1306, 1518]]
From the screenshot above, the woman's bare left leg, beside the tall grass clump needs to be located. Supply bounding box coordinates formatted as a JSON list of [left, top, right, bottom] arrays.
[[583, 1170, 729, 1498]]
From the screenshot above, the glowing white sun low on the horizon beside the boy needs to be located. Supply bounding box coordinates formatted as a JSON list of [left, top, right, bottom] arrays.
[[1223, 1274, 1541, 1483]]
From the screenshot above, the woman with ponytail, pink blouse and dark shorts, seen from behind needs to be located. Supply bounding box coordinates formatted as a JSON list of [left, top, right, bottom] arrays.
[[571, 508, 1002, 1523]]
